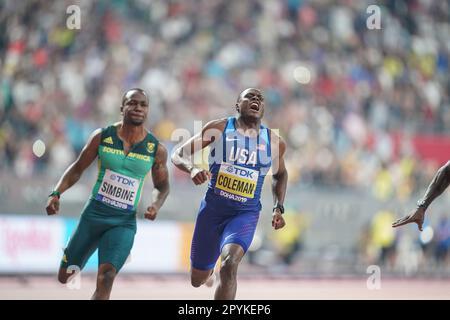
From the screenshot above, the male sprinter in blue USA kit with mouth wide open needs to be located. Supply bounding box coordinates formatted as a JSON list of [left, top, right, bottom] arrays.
[[172, 88, 288, 300]]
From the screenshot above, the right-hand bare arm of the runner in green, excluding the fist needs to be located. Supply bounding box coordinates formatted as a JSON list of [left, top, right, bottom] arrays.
[[152, 143, 170, 210]]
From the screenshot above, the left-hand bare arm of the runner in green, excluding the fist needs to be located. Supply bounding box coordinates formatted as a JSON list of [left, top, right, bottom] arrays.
[[54, 129, 101, 194]]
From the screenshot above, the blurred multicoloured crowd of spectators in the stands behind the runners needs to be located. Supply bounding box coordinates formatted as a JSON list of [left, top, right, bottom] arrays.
[[0, 0, 450, 276]]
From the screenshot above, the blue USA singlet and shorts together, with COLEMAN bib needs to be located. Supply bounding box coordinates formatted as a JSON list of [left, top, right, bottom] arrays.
[[191, 117, 272, 270]]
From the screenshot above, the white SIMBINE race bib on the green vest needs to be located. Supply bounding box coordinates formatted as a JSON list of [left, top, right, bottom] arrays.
[[96, 169, 140, 210]]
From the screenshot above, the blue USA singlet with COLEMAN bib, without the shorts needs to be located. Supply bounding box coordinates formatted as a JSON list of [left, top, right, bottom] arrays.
[[207, 117, 272, 211]]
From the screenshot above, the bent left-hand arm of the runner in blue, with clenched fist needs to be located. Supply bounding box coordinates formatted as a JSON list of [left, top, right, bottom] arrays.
[[171, 119, 226, 184]]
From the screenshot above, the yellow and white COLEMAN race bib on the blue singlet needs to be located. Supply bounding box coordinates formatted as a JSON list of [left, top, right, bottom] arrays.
[[215, 163, 259, 202]]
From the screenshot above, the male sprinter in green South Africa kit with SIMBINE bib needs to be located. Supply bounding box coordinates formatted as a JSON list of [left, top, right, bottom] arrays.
[[46, 88, 169, 299]]
